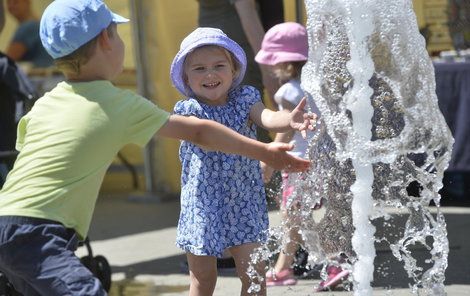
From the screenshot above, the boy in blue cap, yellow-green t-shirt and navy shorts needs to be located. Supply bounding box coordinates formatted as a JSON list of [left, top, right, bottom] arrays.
[[0, 0, 316, 296]]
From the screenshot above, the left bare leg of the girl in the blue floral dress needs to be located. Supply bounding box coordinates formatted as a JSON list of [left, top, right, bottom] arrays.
[[186, 253, 217, 296]]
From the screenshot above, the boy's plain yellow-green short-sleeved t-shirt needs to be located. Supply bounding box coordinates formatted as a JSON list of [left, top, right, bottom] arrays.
[[0, 81, 169, 238]]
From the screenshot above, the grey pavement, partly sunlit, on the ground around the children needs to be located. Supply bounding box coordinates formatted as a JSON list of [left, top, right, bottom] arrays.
[[77, 196, 470, 296]]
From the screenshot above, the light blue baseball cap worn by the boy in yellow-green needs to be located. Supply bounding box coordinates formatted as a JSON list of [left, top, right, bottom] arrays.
[[39, 0, 129, 59]]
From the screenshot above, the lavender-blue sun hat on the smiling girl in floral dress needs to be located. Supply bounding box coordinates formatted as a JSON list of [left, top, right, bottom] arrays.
[[170, 27, 246, 96]]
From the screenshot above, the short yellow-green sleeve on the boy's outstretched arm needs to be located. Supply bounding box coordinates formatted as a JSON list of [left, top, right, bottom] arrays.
[[124, 92, 170, 146]]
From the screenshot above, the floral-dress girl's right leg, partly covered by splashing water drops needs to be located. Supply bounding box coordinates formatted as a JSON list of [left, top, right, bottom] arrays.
[[229, 243, 266, 296]]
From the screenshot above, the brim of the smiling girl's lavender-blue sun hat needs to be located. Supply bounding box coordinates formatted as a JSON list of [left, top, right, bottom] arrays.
[[170, 36, 246, 96]]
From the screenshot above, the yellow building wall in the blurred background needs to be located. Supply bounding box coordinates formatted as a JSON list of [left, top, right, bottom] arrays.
[[0, 0, 460, 199]]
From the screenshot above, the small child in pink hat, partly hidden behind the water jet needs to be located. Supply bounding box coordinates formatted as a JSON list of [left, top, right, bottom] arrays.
[[255, 22, 318, 286]]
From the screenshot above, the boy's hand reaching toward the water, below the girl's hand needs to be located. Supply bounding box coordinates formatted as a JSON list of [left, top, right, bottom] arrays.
[[263, 142, 310, 172]]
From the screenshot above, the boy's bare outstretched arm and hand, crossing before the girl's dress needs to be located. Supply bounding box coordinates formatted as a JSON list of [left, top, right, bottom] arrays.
[[157, 115, 310, 172]]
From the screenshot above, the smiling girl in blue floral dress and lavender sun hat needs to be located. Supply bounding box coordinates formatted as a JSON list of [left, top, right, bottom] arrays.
[[171, 28, 314, 296]]
